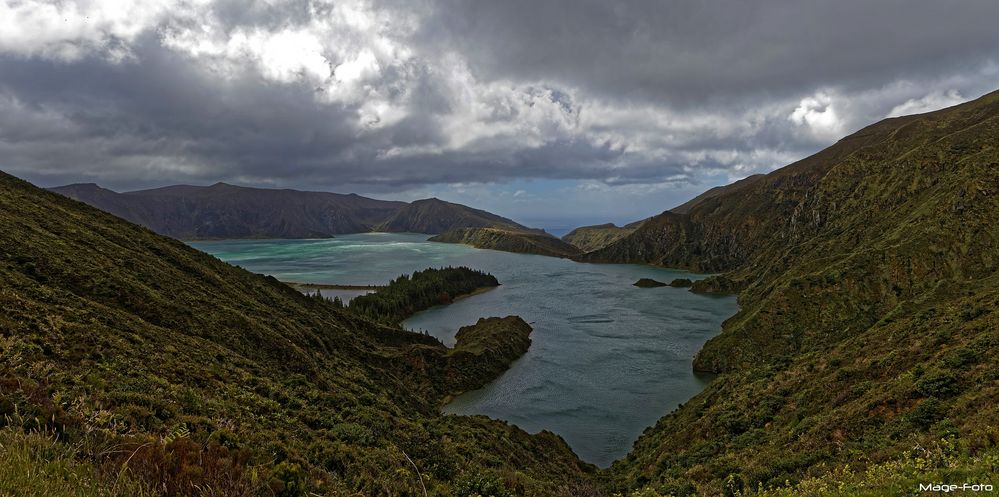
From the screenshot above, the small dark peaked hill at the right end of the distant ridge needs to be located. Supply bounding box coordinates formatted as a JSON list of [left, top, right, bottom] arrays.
[[372, 198, 535, 235]]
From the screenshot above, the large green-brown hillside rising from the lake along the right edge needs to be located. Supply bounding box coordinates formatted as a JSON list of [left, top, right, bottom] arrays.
[[600, 93, 999, 494]]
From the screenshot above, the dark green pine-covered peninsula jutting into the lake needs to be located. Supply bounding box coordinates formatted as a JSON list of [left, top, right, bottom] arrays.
[[347, 266, 499, 324]]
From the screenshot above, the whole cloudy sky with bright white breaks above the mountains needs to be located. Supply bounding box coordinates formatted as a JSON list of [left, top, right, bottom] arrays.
[[0, 0, 999, 228]]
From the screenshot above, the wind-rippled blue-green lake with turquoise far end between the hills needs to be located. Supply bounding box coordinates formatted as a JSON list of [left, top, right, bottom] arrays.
[[192, 233, 736, 466]]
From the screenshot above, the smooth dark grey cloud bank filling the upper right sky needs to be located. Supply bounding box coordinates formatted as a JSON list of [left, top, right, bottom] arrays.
[[421, 0, 999, 105]]
